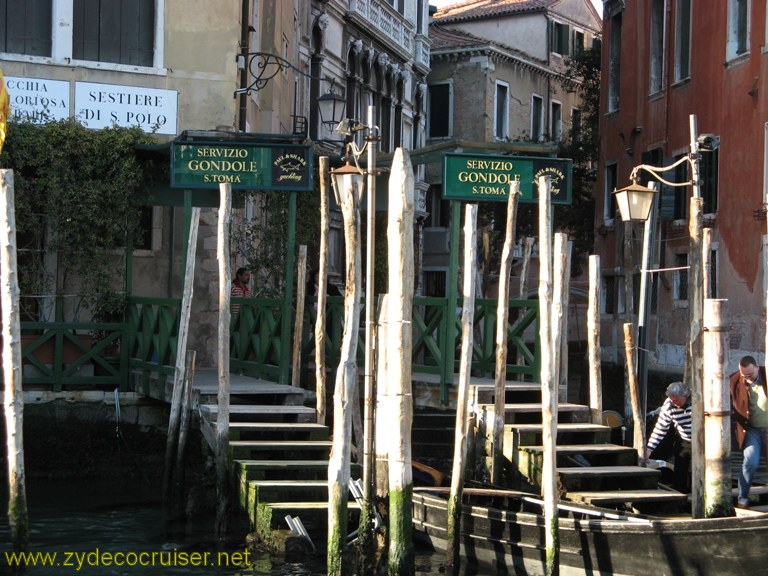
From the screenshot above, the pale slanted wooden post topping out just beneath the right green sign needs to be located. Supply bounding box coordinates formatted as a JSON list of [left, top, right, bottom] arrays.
[[445, 204, 477, 574]]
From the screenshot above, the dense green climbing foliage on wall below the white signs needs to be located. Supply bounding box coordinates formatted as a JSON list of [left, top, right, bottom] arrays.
[[0, 119, 160, 317]]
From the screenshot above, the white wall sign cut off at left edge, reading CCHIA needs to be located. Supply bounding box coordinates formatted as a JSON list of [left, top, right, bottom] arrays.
[[5, 76, 69, 122]]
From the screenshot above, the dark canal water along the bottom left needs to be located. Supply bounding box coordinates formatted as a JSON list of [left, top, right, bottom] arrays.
[[0, 475, 488, 576]]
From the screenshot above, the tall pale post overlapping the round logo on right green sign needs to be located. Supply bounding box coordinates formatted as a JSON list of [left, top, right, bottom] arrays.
[[539, 176, 560, 576]]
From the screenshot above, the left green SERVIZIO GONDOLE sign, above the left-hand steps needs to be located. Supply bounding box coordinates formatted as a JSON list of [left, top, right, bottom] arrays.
[[171, 142, 313, 192]]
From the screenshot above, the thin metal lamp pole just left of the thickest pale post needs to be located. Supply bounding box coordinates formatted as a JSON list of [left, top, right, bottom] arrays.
[[363, 106, 378, 509]]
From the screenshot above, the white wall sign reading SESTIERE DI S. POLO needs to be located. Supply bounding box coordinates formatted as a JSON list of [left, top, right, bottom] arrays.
[[75, 82, 178, 134]]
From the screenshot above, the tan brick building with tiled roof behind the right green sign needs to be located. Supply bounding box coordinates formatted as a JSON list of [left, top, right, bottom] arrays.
[[424, 0, 600, 297]]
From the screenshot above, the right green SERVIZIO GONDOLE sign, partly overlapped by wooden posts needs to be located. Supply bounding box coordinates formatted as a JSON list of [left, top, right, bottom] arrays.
[[443, 154, 573, 204]]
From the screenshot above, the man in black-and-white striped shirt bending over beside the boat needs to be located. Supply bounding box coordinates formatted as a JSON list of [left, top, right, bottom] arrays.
[[645, 382, 691, 492]]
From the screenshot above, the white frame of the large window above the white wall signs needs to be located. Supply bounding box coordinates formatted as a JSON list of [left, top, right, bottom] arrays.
[[6, 0, 166, 75]]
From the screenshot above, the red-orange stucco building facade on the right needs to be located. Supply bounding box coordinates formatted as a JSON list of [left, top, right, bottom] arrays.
[[595, 0, 768, 372]]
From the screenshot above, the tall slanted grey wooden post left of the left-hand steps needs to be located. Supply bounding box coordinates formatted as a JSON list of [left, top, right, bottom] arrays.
[[163, 206, 200, 511]]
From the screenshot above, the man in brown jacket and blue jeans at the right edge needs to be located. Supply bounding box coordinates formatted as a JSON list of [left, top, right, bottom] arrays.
[[730, 356, 768, 508]]
